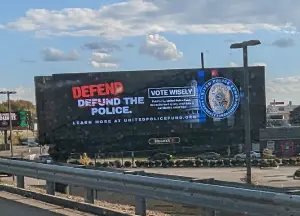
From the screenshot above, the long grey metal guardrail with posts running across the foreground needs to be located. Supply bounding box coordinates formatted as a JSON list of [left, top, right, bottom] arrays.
[[0, 158, 300, 216]]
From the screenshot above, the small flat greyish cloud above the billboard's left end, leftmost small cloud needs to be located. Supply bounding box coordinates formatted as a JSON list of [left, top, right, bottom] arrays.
[[42, 47, 80, 61]]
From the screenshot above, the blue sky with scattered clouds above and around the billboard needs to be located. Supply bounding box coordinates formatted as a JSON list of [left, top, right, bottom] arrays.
[[0, 0, 300, 104]]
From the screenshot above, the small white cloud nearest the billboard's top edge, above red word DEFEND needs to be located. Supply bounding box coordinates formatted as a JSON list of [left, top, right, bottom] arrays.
[[90, 52, 119, 68]]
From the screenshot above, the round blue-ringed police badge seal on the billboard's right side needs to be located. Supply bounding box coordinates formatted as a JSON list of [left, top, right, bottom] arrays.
[[199, 77, 240, 119]]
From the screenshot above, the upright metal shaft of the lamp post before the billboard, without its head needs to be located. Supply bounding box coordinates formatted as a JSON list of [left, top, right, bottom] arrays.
[[243, 46, 252, 184]]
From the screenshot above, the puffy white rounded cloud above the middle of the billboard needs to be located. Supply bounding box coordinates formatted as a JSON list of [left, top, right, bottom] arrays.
[[140, 34, 183, 61]]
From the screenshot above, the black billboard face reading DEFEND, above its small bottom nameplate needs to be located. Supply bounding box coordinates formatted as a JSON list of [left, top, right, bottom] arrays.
[[35, 67, 266, 149]]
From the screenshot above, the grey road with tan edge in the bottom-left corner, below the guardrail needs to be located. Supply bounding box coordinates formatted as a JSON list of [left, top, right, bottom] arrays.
[[0, 191, 94, 216]]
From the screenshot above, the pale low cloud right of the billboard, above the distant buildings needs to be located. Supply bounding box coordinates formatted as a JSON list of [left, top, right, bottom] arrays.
[[266, 76, 300, 105]]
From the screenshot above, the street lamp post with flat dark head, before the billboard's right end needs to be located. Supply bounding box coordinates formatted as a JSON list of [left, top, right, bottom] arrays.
[[230, 40, 261, 184]]
